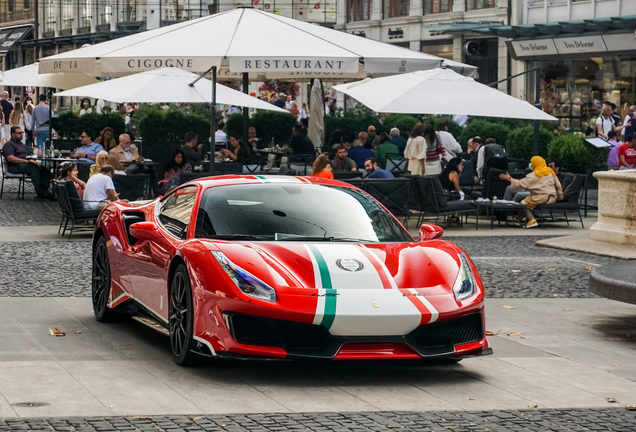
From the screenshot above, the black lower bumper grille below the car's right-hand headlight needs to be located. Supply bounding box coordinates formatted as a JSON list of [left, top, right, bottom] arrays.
[[406, 313, 484, 348]]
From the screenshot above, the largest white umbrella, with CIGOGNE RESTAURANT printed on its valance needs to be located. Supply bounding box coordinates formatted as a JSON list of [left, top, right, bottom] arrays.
[[40, 8, 470, 77]]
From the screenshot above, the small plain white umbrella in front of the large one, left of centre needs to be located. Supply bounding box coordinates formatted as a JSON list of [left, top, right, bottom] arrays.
[[55, 68, 287, 112]]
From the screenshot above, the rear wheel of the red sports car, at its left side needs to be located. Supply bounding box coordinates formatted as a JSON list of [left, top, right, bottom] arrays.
[[91, 237, 119, 322]]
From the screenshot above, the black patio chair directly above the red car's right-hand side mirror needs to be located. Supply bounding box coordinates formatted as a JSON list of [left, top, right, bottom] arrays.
[[415, 176, 477, 225]]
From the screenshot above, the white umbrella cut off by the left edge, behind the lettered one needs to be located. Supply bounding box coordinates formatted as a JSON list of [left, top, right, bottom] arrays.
[[0, 63, 97, 89]]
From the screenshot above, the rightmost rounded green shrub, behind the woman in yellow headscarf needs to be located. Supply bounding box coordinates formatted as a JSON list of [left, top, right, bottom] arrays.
[[548, 135, 609, 167]]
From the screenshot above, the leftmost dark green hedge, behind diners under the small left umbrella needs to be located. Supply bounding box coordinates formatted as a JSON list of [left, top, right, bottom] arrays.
[[52, 110, 126, 139]]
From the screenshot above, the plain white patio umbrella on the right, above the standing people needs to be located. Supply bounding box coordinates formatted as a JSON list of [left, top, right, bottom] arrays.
[[334, 69, 557, 121]]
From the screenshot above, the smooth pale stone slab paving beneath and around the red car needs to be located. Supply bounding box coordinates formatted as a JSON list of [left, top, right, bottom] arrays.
[[0, 298, 636, 418]]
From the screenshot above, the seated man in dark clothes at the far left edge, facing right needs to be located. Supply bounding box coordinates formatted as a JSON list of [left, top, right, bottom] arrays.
[[2, 126, 53, 200]]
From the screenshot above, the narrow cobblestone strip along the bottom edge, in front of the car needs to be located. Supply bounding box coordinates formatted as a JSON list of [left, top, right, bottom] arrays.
[[0, 408, 636, 432]]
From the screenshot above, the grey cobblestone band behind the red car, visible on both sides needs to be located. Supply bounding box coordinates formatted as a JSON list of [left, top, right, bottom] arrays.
[[0, 236, 612, 298]]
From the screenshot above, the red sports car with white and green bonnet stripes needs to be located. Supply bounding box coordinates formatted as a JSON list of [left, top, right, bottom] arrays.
[[92, 176, 492, 365]]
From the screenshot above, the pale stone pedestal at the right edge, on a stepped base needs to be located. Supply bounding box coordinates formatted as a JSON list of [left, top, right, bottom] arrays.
[[590, 170, 636, 246]]
